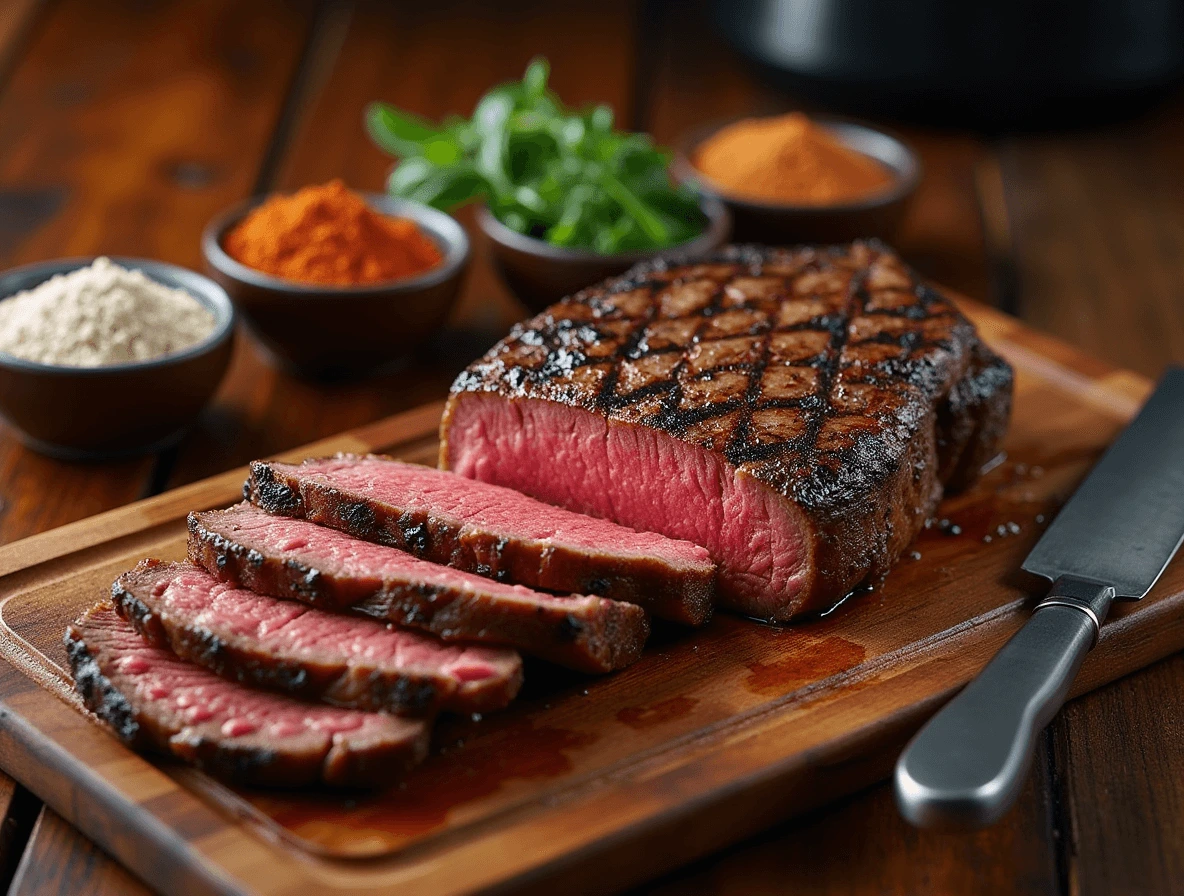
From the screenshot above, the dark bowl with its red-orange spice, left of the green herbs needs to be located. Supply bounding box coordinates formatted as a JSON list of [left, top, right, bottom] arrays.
[[201, 180, 469, 378]]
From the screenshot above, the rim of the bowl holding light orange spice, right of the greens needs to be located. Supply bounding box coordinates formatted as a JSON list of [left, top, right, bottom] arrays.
[[670, 112, 924, 214]]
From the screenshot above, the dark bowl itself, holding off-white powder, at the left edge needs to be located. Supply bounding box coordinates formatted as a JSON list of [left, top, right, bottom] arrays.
[[0, 257, 234, 460]]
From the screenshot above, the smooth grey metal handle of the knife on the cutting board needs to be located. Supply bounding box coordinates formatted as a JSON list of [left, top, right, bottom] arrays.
[[895, 576, 1114, 830]]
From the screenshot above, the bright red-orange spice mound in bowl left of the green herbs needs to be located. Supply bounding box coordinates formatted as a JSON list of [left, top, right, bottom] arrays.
[[223, 180, 443, 286]]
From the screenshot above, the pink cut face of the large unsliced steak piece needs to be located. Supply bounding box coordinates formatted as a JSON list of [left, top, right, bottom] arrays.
[[445, 393, 807, 617]]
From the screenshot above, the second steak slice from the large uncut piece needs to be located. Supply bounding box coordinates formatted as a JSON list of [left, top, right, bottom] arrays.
[[189, 504, 649, 672]]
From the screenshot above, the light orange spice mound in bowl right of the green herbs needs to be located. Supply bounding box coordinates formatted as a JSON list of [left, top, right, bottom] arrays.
[[693, 112, 893, 206]]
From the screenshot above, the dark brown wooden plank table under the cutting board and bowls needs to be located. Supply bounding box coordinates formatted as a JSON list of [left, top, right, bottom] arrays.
[[0, 0, 1184, 896]]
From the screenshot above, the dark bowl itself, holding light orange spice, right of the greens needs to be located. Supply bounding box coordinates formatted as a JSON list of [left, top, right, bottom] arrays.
[[674, 117, 921, 244]]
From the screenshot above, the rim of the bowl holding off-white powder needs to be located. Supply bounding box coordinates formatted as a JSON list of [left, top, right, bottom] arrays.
[[0, 254, 238, 376]]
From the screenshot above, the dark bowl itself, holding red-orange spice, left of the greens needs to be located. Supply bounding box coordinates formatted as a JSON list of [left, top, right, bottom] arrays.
[[201, 193, 469, 378]]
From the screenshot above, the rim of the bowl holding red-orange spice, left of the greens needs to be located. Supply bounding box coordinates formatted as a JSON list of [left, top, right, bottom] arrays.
[[201, 191, 471, 298]]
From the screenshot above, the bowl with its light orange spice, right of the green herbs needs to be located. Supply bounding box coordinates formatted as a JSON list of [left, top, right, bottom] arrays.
[[675, 112, 921, 243]]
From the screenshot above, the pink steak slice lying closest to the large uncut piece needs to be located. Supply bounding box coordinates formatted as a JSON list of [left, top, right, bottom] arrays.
[[243, 455, 715, 625]]
